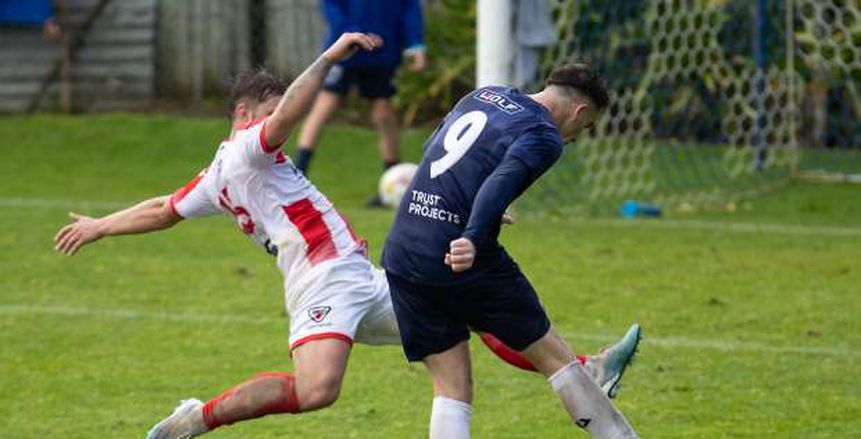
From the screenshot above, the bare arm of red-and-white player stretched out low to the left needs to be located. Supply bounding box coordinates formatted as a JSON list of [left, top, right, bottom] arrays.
[[54, 196, 182, 256]]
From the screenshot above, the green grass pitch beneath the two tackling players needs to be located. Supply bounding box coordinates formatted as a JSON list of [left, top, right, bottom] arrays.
[[0, 115, 861, 439]]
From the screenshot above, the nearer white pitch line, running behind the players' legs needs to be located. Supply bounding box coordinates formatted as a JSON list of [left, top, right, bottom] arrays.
[[0, 305, 861, 358]]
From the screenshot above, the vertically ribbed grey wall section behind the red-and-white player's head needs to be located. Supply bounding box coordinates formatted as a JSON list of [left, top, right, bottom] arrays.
[[157, 0, 325, 98]]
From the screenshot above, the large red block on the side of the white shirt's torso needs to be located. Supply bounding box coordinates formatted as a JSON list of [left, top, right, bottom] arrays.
[[283, 198, 338, 266]]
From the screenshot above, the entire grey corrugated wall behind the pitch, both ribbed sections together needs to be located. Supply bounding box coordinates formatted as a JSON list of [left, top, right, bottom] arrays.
[[0, 0, 325, 112]]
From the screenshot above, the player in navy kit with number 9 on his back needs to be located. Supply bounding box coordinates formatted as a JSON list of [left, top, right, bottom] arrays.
[[382, 63, 637, 439]]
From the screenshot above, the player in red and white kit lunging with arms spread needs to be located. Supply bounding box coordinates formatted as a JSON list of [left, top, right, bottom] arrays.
[[50, 33, 639, 438]]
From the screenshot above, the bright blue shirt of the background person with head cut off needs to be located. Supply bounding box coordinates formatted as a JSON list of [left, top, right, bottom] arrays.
[[320, 0, 424, 69]]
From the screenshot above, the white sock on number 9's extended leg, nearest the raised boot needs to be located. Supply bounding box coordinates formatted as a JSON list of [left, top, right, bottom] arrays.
[[548, 361, 637, 439]]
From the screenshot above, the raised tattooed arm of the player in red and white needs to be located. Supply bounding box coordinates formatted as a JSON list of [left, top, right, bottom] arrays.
[[265, 32, 383, 149]]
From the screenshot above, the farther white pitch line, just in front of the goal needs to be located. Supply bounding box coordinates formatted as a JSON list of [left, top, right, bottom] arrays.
[[0, 198, 861, 238]]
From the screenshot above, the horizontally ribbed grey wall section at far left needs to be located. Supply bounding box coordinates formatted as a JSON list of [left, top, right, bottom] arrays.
[[0, 0, 157, 112]]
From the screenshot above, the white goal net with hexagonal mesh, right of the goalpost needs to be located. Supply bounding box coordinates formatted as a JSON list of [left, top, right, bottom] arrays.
[[533, 0, 861, 213]]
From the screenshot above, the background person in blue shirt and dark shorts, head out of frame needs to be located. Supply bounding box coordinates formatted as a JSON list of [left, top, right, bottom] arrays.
[[295, 0, 426, 205]]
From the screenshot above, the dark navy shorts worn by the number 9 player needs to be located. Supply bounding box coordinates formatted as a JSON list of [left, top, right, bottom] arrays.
[[386, 259, 550, 361]]
